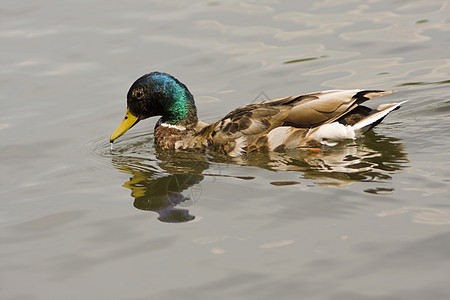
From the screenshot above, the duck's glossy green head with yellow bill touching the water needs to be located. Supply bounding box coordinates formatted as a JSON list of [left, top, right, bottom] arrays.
[[110, 72, 198, 143]]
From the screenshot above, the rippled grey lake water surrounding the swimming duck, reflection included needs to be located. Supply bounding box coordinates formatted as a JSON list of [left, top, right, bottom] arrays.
[[0, 0, 450, 300]]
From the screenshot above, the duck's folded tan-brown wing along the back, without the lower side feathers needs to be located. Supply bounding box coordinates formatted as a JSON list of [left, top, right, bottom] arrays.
[[208, 90, 393, 134]]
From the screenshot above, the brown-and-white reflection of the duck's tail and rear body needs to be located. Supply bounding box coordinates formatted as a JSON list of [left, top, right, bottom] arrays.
[[243, 132, 408, 185]]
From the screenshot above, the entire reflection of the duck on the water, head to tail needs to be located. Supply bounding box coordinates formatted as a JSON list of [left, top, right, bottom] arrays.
[[112, 132, 408, 222]]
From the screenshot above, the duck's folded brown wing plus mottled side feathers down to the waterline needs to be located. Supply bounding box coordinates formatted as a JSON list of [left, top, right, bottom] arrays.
[[199, 90, 392, 156]]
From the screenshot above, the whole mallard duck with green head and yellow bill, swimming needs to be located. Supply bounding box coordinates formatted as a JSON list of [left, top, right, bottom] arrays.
[[110, 72, 404, 157]]
